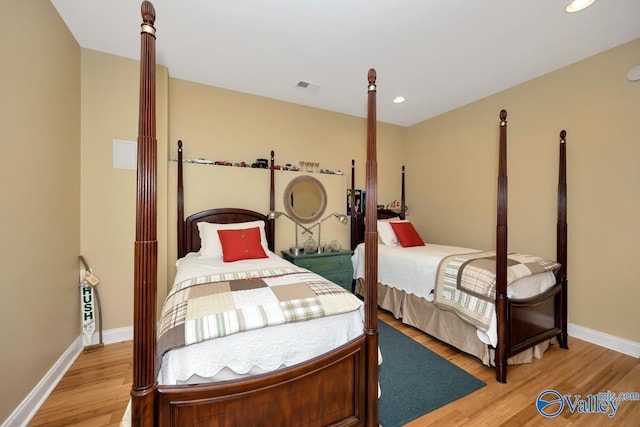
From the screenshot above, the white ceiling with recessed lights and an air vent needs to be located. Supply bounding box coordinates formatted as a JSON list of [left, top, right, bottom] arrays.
[[51, 0, 640, 126]]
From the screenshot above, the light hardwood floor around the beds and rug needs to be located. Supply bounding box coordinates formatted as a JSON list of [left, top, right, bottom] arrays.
[[29, 312, 640, 427]]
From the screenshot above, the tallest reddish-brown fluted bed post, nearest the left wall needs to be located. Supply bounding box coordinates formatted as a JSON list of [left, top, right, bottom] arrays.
[[131, 1, 158, 426]]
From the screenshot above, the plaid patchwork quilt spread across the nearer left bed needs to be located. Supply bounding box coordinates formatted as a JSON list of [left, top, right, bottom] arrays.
[[158, 266, 362, 358]]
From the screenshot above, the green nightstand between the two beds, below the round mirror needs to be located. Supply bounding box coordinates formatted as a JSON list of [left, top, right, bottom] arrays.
[[281, 250, 353, 291]]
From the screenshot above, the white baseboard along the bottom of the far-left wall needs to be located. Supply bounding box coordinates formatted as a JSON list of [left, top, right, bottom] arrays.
[[2, 336, 82, 427]]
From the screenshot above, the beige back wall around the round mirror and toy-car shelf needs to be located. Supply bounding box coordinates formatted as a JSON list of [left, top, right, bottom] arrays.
[[168, 77, 407, 284]]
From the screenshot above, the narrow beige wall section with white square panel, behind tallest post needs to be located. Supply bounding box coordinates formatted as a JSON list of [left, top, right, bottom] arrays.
[[80, 49, 168, 330]]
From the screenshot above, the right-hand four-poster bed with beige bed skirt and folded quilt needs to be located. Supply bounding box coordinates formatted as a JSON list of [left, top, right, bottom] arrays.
[[351, 110, 568, 382]]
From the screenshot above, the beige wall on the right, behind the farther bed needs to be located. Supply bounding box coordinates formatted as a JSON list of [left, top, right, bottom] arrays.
[[407, 39, 640, 342]]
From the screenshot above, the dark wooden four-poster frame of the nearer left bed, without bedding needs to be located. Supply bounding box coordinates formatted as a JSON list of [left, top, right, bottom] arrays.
[[130, 1, 378, 426]]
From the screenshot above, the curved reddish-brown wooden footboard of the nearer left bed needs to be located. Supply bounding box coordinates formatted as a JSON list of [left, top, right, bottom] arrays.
[[157, 335, 366, 427]]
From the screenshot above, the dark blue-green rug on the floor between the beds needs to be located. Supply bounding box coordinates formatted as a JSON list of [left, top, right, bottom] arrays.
[[378, 321, 485, 427]]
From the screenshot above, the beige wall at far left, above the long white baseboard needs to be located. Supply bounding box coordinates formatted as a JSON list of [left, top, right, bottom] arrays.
[[0, 0, 80, 422]]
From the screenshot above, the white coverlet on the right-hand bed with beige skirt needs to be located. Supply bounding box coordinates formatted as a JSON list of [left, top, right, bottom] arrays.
[[351, 243, 556, 347]]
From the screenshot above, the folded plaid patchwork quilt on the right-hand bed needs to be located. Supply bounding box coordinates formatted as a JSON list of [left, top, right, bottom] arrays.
[[433, 251, 560, 332]]
